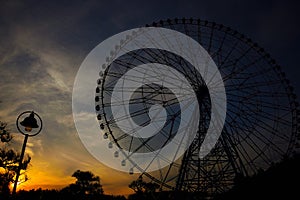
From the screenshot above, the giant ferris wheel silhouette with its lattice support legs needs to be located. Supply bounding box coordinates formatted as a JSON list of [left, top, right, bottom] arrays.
[[95, 18, 299, 196]]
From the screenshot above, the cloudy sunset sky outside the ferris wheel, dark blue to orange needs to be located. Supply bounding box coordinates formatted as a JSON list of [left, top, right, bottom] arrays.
[[0, 0, 300, 194]]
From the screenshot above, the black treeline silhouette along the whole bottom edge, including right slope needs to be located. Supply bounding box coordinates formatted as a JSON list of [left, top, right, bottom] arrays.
[[4, 155, 300, 200]]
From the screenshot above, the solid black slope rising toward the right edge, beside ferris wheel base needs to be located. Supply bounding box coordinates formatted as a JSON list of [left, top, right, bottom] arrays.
[[215, 154, 300, 200]]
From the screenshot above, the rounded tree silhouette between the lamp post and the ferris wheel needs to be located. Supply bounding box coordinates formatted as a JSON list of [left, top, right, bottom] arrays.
[[63, 170, 103, 199]]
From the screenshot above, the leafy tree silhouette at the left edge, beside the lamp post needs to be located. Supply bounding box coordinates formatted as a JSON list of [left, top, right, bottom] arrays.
[[0, 121, 31, 199]]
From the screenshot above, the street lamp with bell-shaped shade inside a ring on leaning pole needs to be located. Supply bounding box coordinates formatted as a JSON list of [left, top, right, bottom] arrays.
[[12, 111, 43, 195]]
